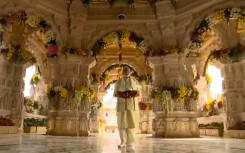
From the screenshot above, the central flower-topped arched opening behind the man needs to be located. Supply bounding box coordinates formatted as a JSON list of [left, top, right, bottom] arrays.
[[90, 30, 153, 133]]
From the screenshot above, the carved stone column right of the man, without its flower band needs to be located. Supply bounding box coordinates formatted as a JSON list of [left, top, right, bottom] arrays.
[[149, 55, 199, 138]]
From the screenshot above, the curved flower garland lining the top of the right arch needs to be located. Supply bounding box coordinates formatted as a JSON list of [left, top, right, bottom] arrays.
[[189, 8, 245, 56]]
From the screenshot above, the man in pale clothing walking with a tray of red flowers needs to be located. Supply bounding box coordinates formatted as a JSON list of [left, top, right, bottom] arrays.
[[114, 67, 139, 151]]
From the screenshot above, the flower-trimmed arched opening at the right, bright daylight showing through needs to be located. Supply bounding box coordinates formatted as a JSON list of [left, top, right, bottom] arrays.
[[191, 8, 245, 132]]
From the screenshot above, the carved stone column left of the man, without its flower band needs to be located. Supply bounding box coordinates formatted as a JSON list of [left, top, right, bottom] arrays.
[[47, 55, 95, 136]]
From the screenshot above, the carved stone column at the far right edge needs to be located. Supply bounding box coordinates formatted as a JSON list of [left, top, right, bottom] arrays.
[[221, 61, 245, 136]]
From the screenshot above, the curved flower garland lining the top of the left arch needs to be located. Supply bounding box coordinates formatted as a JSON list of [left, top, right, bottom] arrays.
[[0, 11, 58, 57]]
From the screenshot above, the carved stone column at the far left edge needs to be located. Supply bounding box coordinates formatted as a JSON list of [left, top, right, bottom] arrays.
[[0, 57, 25, 133]]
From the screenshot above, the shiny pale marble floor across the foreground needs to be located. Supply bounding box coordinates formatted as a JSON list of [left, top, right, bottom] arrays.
[[0, 133, 245, 153]]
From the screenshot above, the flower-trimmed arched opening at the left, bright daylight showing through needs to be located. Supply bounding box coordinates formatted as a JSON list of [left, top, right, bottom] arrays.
[[0, 11, 58, 132]]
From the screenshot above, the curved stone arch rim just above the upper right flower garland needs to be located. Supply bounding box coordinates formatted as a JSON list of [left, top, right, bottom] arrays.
[[182, 1, 245, 52]]
